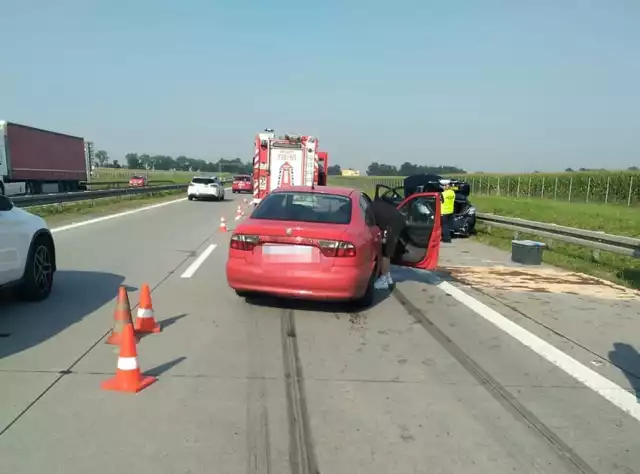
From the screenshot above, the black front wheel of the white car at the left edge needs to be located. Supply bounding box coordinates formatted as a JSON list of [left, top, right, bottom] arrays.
[[18, 237, 54, 301]]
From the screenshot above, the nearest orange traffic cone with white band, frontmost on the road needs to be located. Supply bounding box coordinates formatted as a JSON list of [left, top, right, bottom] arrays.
[[100, 323, 156, 393]]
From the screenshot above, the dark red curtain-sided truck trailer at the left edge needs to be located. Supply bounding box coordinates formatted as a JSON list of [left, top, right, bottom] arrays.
[[0, 121, 93, 194]]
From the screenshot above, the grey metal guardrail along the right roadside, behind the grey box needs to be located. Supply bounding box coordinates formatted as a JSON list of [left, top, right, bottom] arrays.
[[476, 213, 640, 258]]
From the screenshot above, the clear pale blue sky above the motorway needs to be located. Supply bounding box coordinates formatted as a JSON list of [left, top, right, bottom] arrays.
[[0, 0, 640, 172]]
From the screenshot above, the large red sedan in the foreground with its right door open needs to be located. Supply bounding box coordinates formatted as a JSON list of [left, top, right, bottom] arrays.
[[226, 186, 441, 307]]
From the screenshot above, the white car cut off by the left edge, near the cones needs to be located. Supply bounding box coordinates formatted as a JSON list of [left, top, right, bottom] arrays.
[[0, 195, 56, 301]]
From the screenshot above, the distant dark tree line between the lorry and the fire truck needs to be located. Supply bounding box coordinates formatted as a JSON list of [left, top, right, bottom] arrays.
[[94, 150, 253, 174]]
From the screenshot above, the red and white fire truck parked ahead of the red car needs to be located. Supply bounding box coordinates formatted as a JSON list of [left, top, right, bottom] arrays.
[[253, 129, 326, 205]]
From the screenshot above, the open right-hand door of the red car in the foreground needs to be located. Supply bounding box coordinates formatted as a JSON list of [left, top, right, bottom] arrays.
[[376, 184, 442, 270]]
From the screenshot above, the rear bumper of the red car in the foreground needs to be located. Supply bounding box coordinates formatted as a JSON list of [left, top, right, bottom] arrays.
[[226, 258, 370, 301]]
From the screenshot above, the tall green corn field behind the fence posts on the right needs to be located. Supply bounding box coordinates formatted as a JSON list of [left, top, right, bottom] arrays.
[[348, 171, 640, 206]]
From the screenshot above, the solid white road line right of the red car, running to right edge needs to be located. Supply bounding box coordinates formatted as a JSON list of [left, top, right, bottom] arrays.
[[418, 272, 640, 421]]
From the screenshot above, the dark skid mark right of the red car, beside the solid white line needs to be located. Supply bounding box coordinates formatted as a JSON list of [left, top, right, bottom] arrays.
[[393, 288, 596, 474]]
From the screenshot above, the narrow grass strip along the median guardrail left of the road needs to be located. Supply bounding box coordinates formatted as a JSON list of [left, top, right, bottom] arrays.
[[25, 189, 185, 227]]
